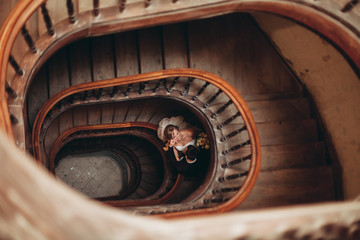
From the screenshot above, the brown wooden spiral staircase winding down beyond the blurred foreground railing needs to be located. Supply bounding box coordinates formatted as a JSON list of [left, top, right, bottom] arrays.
[[1, 0, 360, 238]]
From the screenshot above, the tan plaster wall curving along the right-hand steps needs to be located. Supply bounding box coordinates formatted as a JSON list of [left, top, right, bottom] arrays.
[[253, 13, 360, 199]]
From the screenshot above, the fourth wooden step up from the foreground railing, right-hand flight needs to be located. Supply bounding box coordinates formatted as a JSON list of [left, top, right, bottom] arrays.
[[247, 98, 311, 122]]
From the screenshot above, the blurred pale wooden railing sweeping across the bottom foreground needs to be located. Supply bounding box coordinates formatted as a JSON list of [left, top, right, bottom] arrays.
[[0, 132, 360, 240]]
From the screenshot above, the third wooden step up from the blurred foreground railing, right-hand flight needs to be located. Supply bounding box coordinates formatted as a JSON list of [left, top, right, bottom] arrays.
[[256, 119, 318, 146]]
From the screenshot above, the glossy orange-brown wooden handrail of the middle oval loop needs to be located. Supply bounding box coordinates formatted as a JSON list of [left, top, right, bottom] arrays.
[[32, 69, 261, 216]]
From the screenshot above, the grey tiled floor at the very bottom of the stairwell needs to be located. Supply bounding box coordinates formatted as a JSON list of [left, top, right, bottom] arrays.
[[55, 154, 123, 197]]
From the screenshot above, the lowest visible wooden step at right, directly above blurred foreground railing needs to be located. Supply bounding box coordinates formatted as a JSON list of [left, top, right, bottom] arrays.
[[236, 166, 335, 210]]
